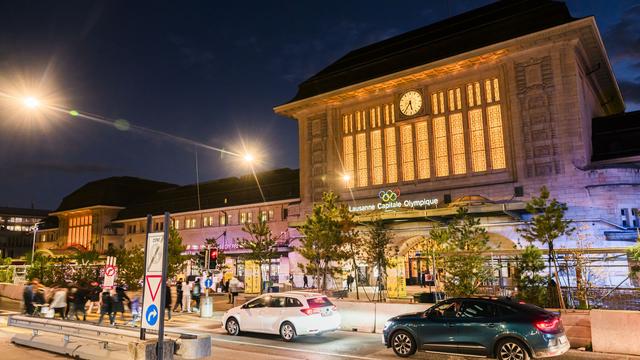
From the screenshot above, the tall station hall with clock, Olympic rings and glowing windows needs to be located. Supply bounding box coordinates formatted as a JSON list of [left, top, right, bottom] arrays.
[[274, 0, 640, 284]]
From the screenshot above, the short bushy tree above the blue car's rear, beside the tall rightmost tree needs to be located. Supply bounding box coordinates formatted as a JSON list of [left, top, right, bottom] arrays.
[[515, 244, 547, 306]]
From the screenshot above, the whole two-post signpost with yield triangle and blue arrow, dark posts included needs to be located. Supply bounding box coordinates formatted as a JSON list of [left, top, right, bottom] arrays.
[[140, 212, 171, 359]]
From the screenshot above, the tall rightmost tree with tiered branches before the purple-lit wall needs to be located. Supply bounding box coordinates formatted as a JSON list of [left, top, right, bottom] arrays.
[[517, 186, 575, 306]]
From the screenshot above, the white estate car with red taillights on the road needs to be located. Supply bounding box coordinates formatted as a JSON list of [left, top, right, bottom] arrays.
[[222, 291, 341, 341]]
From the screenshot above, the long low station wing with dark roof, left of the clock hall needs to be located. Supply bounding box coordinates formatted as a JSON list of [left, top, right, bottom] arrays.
[[37, 169, 300, 280]]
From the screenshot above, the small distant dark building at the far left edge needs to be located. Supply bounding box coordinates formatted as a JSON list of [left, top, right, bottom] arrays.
[[0, 207, 49, 258]]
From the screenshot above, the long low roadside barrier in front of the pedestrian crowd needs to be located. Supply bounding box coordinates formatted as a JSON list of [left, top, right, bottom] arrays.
[[7, 315, 211, 359]]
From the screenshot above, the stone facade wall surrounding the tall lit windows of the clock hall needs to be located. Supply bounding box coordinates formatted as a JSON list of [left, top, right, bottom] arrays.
[[292, 20, 640, 253]]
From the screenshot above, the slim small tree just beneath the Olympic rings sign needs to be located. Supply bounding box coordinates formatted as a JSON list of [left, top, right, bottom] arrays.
[[362, 220, 393, 300]]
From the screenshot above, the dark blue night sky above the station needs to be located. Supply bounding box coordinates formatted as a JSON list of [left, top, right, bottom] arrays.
[[0, 0, 640, 209]]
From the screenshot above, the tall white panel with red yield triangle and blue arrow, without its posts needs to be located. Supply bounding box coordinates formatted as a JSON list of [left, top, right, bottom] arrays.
[[142, 232, 167, 330]]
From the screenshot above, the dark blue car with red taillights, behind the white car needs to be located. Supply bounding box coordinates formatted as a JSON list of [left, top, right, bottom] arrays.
[[383, 298, 569, 360]]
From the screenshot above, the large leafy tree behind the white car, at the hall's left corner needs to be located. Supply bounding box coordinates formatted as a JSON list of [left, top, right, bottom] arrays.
[[297, 192, 355, 290]]
